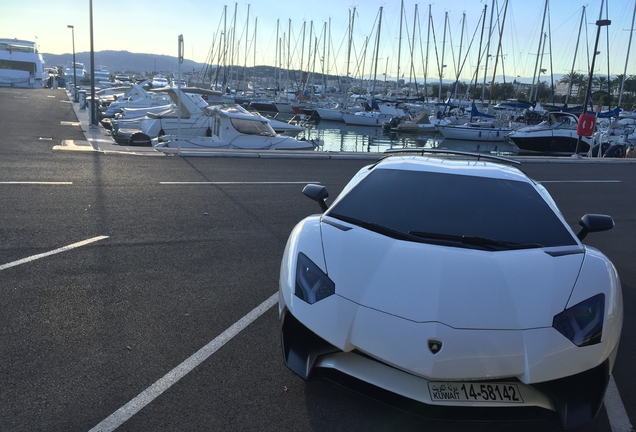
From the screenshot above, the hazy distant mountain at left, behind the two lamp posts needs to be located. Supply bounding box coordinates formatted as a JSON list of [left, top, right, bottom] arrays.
[[42, 51, 205, 73]]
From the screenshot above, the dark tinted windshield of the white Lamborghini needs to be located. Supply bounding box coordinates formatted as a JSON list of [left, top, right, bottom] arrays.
[[328, 169, 577, 248]]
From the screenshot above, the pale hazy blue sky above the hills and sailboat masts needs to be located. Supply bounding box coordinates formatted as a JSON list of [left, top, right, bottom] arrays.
[[0, 0, 636, 81]]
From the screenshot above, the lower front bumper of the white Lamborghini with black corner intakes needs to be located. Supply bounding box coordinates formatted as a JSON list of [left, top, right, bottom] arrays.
[[281, 310, 610, 428]]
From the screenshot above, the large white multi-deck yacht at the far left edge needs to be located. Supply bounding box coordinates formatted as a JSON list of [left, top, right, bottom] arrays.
[[0, 39, 48, 87]]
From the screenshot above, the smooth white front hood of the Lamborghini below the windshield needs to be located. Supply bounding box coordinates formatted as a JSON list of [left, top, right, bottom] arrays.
[[322, 223, 584, 330]]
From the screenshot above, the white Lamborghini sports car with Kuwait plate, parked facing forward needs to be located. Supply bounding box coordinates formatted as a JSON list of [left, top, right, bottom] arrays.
[[279, 152, 623, 428]]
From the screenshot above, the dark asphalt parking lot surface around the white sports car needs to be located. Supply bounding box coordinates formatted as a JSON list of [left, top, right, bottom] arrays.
[[0, 89, 636, 432]]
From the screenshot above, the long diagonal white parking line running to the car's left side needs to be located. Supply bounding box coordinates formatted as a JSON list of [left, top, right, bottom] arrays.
[[89, 293, 278, 432]]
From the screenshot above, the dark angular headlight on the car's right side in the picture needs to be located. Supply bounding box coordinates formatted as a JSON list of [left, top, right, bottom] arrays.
[[552, 294, 605, 347]]
